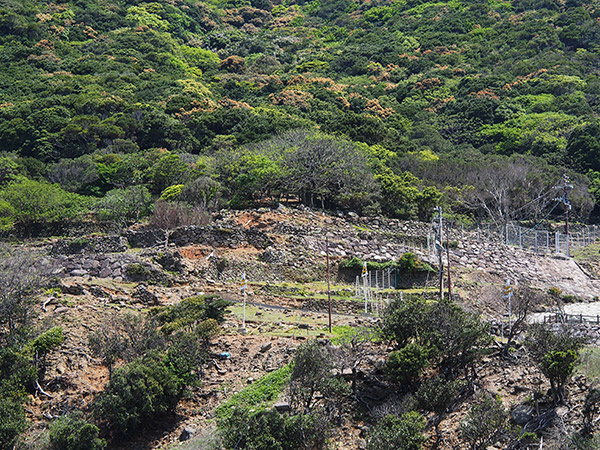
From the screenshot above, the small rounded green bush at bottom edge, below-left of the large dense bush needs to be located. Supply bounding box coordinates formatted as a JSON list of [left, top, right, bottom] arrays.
[[49, 411, 106, 450]]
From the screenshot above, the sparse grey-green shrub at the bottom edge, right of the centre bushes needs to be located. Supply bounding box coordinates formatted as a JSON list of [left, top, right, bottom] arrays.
[[460, 394, 507, 450]]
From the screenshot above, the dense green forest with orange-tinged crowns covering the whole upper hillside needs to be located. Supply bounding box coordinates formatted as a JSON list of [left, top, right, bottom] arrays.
[[0, 0, 600, 230]]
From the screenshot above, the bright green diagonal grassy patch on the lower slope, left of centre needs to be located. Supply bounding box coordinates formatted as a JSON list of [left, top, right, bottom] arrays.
[[215, 364, 292, 421]]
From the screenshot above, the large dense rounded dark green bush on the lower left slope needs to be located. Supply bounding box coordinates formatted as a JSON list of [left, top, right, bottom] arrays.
[[95, 354, 185, 435]]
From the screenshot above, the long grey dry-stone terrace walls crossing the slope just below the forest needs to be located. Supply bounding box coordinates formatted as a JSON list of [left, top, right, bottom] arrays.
[[47, 208, 600, 298]]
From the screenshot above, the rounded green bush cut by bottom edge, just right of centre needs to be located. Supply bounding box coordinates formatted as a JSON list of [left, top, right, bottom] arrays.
[[367, 411, 426, 450]]
